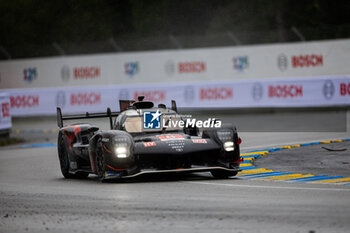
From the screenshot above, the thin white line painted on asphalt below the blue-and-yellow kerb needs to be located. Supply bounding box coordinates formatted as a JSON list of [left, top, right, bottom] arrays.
[[187, 181, 350, 191]]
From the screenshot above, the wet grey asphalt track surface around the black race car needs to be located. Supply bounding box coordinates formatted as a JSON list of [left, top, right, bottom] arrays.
[[0, 111, 350, 233]]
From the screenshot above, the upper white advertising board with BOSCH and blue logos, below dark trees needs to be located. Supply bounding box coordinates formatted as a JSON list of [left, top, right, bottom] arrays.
[[0, 39, 350, 89]]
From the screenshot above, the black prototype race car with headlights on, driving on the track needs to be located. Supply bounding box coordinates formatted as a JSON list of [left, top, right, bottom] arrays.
[[57, 97, 243, 180]]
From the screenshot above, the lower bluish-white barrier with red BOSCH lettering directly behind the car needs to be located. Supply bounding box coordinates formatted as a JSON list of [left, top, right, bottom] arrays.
[[2, 76, 350, 116]]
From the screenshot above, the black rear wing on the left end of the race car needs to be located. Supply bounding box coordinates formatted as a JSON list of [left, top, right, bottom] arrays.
[[57, 108, 119, 129]]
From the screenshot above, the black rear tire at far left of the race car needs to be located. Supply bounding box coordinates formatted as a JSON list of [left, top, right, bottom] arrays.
[[57, 133, 89, 179]]
